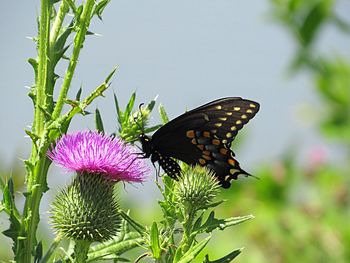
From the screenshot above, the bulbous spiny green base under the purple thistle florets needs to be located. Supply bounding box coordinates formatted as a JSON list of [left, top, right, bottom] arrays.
[[51, 173, 121, 242]]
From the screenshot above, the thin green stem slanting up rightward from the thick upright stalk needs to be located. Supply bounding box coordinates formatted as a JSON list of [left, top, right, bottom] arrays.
[[52, 0, 95, 120]]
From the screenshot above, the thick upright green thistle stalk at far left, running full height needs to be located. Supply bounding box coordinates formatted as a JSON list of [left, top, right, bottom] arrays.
[[16, 0, 51, 263]]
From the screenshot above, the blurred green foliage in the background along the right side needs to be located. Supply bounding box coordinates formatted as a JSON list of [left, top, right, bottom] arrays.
[[202, 0, 350, 263]]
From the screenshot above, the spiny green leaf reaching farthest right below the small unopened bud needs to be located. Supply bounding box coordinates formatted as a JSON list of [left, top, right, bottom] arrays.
[[198, 211, 254, 233]]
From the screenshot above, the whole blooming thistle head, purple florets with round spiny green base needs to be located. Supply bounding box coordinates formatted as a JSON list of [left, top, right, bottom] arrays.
[[48, 131, 148, 245]]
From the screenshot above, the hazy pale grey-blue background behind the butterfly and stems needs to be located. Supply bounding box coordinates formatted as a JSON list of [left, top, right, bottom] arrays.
[[0, 0, 350, 196]]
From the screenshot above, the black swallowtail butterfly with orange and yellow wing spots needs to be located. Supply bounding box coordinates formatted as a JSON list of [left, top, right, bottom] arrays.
[[139, 97, 259, 188]]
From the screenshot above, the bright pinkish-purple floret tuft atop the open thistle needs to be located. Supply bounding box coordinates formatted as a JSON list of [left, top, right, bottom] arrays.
[[48, 131, 149, 182]]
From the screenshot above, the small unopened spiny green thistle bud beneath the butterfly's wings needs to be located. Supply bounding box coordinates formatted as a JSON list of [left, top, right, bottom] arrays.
[[174, 166, 220, 211]]
